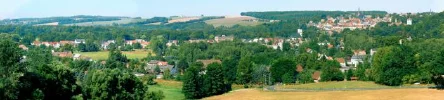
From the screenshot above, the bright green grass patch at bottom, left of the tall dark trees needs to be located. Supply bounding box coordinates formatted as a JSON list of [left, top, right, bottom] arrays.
[[148, 80, 185, 100]]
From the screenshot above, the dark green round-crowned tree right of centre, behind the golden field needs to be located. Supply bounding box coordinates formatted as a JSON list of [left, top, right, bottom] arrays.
[[270, 58, 296, 83]]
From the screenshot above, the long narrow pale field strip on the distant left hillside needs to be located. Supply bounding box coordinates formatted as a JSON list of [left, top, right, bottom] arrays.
[[65, 18, 146, 26]]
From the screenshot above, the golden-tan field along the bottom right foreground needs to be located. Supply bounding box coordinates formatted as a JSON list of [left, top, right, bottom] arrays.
[[205, 89, 444, 100]]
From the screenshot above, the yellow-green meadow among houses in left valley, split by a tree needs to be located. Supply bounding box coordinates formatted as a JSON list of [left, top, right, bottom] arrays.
[[78, 50, 151, 60]]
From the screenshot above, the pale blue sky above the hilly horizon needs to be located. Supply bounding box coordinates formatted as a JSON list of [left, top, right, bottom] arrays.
[[0, 0, 444, 19]]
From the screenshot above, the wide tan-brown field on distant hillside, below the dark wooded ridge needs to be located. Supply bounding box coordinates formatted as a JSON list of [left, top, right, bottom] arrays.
[[205, 16, 263, 27]]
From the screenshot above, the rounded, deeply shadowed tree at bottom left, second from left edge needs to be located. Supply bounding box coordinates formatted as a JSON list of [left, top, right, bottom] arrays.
[[18, 62, 81, 99]]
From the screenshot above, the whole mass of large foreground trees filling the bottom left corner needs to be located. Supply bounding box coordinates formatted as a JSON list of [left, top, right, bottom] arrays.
[[0, 38, 164, 100]]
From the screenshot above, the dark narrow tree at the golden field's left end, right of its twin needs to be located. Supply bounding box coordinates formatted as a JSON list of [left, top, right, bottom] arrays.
[[203, 63, 227, 96]]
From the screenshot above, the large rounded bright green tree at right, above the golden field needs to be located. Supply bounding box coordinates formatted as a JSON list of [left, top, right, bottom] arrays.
[[371, 46, 416, 86]]
